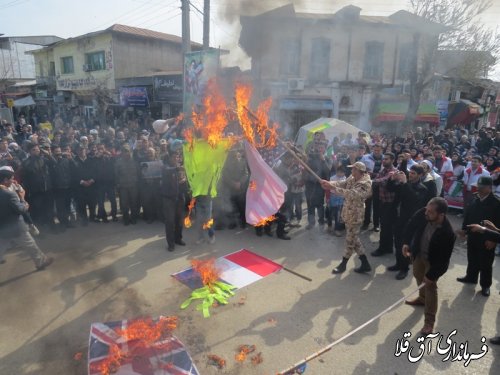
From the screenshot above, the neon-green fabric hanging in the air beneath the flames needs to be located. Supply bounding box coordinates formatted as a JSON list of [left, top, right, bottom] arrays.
[[183, 139, 230, 198]]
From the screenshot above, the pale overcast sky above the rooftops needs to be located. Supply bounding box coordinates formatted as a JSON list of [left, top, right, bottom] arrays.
[[0, 0, 500, 80]]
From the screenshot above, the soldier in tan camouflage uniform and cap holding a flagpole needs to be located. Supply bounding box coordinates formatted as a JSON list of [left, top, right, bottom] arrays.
[[321, 162, 372, 274]]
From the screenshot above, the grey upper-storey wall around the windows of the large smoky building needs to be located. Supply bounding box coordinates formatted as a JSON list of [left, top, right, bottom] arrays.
[[256, 20, 412, 85]]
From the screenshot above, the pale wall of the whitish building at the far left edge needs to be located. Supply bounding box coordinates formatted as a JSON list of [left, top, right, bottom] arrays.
[[0, 40, 42, 79]]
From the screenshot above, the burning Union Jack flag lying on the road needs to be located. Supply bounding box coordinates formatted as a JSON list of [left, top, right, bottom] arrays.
[[88, 320, 199, 375]]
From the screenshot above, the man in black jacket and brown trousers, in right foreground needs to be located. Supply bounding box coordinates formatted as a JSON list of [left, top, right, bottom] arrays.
[[403, 197, 455, 335]]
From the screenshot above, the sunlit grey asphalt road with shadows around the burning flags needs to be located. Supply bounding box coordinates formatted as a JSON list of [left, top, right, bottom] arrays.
[[0, 212, 500, 375]]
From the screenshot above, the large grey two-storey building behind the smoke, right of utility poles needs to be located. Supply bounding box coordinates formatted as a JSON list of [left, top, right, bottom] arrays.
[[240, 5, 444, 135]]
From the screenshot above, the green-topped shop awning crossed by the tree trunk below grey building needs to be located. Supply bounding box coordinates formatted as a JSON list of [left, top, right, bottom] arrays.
[[372, 101, 439, 124]]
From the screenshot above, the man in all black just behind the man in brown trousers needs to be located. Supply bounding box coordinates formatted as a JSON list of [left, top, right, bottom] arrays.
[[387, 164, 433, 280]]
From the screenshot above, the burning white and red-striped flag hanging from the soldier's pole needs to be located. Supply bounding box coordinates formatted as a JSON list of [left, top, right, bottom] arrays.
[[245, 142, 287, 225]]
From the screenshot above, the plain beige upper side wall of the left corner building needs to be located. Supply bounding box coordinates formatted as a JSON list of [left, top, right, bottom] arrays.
[[113, 34, 182, 79]]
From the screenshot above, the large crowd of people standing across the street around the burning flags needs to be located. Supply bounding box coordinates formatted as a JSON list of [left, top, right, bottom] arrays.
[[0, 114, 500, 340]]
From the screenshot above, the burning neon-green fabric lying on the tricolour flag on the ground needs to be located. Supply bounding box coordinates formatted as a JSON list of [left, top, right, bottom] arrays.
[[181, 259, 236, 318]]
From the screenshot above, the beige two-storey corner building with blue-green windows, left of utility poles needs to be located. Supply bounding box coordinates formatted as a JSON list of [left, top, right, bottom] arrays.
[[33, 24, 202, 119]]
